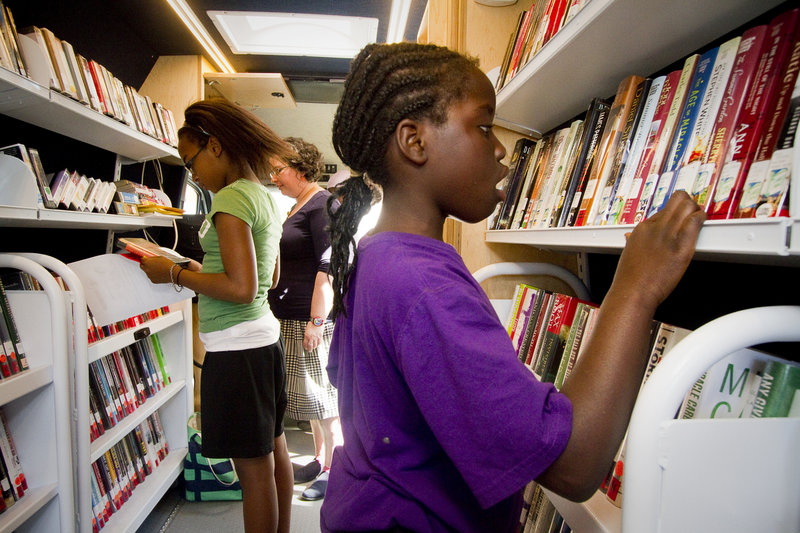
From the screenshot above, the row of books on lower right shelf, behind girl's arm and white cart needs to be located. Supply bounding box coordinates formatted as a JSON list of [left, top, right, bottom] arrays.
[[505, 284, 800, 506]]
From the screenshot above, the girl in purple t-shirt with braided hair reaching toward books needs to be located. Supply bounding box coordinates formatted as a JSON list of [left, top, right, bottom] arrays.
[[321, 43, 705, 532]]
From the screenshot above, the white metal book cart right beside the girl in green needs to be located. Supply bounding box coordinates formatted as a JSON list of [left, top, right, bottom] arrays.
[[24, 254, 194, 533]]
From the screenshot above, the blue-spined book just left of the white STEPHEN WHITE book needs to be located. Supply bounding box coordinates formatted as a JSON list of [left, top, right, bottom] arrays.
[[647, 47, 720, 216]]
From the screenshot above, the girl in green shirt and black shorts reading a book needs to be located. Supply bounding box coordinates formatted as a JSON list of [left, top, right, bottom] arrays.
[[142, 99, 294, 533]]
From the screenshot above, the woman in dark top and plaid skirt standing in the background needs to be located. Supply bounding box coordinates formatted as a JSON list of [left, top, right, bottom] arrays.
[[269, 137, 342, 500]]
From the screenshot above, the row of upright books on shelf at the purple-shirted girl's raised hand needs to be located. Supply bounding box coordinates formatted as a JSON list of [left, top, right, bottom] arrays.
[[489, 8, 800, 229]]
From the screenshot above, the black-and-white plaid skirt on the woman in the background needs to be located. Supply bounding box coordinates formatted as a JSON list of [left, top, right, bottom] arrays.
[[280, 320, 339, 420]]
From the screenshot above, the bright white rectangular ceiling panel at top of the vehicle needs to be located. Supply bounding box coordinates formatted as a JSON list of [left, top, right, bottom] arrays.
[[207, 11, 378, 58]]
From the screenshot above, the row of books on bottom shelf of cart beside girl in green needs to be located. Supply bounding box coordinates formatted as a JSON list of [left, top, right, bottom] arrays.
[[90, 412, 169, 532]]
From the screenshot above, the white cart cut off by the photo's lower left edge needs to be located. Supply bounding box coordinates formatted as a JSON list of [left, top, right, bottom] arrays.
[[0, 254, 75, 532]]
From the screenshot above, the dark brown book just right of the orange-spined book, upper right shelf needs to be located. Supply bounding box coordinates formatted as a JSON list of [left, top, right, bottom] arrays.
[[590, 78, 653, 226]]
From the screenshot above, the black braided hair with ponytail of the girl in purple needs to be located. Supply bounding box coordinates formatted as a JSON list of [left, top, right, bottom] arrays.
[[328, 43, 478, 317]]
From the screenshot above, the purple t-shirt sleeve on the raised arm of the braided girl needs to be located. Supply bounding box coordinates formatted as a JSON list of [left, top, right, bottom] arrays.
[[396, 266, 572, 508]]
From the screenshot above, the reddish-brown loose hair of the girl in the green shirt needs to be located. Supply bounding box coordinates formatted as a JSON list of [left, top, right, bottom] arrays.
[[178, 98, 296, 184]]
